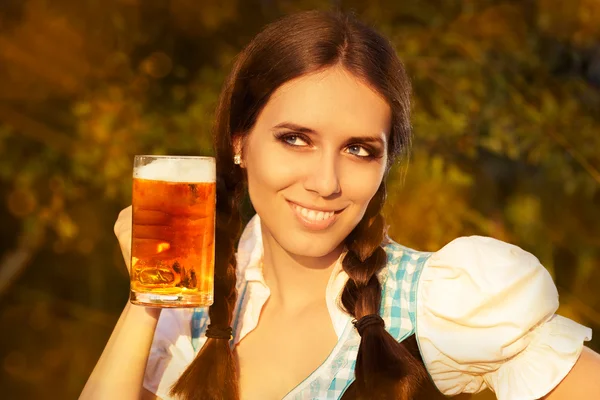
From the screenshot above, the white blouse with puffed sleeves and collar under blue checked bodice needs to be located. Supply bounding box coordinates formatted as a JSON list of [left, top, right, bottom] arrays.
[[144, 216, 592, 400]]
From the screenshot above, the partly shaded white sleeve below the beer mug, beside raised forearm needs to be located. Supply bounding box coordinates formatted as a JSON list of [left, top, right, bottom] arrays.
[[143, 308, 195, 400]]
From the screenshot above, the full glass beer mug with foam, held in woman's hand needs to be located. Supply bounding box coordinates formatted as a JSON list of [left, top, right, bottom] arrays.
[[130, 156, 216, 307]]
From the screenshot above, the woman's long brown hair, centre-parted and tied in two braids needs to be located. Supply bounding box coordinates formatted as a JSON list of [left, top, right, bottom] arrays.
[[171, 11, 426, 400]]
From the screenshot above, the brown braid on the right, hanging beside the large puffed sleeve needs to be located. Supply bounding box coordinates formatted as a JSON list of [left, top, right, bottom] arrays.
[[341, 183, 427, 400]]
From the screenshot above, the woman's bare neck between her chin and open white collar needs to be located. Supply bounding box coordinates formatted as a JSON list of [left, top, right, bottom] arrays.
[[262, 223, 343, 312]]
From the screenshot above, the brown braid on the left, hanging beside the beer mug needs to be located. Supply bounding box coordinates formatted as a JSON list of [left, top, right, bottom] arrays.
[[170, 54, 245, 400]]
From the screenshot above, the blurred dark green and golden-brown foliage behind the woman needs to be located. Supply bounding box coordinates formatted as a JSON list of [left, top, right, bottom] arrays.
[[0, 0, 600, 399]]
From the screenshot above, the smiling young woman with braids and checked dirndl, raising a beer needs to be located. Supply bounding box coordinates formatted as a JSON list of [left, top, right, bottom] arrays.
[[81, 8, 600, 400]]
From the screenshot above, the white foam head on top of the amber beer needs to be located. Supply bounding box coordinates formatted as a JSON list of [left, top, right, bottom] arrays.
[[133, 157, 216, 183]]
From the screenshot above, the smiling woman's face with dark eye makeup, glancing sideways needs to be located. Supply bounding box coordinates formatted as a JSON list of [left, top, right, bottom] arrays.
[[242, 67, 391, 257]]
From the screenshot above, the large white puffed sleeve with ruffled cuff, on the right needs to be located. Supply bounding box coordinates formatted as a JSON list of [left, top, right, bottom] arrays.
[[416, 236, 592, 400]]
